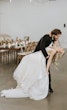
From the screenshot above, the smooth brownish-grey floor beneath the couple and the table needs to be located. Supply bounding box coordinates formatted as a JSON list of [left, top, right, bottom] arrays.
[[0, 49, 67, 110]]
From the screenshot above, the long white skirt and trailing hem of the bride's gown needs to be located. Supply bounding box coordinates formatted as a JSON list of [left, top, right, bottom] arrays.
[[1, 51, 49, 100]]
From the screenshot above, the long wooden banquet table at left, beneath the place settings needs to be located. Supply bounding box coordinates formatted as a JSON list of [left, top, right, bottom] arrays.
[[0, 47, 21, 63]]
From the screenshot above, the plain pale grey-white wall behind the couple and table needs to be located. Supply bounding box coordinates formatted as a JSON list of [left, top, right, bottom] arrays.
[[0, 0, 67, 48]]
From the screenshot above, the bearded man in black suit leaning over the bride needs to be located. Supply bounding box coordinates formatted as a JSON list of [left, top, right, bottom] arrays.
[[34, 29, 62, 93]]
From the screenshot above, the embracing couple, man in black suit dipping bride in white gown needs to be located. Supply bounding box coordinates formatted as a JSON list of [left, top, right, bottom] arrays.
[[1, 29, 64, 100]]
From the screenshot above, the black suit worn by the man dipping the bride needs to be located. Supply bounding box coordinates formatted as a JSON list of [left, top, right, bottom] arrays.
[[34, 34, 53, 90]]
